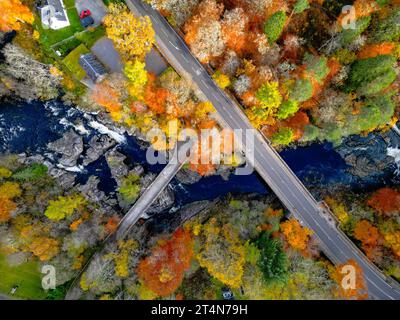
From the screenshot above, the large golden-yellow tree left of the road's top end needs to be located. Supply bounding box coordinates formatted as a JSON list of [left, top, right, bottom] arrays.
[[103, 3, 155, 61]]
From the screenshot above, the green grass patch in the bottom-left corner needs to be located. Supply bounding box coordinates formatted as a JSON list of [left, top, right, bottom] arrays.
[[0, 254, 47, 299]]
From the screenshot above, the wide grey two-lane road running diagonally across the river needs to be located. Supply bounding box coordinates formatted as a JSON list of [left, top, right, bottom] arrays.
[[126, 0, 400, 300]]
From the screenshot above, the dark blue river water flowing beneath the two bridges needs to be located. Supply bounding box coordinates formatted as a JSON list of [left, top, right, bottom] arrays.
[[0, 102, 394, 206]]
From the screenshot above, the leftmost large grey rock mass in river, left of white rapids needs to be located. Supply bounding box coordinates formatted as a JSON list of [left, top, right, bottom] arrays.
[[47, 129, 83, 167]]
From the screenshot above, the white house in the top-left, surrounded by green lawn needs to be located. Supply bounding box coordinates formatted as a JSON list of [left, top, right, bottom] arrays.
[[39, 0, 70, 30]]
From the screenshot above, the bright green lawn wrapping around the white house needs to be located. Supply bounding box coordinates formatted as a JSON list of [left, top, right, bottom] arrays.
[[37, 7, 84, 47]]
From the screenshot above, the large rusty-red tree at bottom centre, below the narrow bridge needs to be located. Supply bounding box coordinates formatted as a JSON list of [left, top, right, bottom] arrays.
[[137, 229, 193, 297]]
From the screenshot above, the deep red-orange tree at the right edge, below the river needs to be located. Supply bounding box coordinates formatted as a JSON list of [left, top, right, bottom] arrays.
[[367, 188, 400, 216]]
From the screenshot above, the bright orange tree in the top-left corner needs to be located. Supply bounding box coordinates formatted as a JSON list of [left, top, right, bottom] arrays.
[[0, 0, 34, 32]]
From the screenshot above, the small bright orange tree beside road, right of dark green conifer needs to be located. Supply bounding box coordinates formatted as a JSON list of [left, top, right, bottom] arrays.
[[280, 219, 312, 251]]
